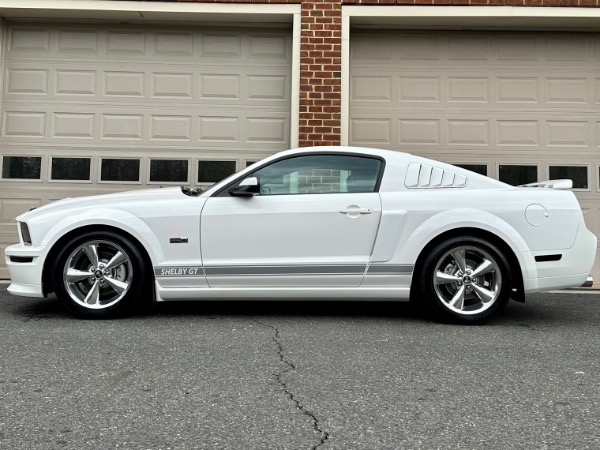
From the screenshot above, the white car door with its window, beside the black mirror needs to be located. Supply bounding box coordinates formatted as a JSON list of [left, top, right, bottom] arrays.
[[200, 153, 384, 287]]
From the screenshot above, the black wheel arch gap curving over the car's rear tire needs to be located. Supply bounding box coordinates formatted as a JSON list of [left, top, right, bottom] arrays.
[[411, 227, 525, 302]]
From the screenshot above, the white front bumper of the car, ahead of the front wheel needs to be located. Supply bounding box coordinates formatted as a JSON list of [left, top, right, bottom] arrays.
[[4, 244, 45, 297]]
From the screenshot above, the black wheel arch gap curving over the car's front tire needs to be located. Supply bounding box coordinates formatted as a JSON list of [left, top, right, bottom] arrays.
[[42, 224, 154, 295]]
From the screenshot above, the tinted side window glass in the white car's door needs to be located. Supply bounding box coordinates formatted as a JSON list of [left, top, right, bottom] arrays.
[[253, 155, 382, 195]]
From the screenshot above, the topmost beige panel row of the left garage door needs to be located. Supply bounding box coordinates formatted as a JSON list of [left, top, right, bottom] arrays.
[[7, 24, 291, 65]]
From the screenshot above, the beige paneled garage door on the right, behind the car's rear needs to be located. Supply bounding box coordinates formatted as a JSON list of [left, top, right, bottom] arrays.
[[350, 30, 600, 282]]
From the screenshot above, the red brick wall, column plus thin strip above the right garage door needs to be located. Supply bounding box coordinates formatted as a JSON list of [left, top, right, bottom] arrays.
[[148, 0, 600, 147]]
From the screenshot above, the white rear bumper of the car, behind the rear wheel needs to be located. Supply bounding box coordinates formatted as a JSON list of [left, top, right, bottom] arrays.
[[523, 223, 597, 294]]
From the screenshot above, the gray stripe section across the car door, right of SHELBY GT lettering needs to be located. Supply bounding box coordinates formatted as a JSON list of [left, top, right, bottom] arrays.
[[204, 264, 367, 277]]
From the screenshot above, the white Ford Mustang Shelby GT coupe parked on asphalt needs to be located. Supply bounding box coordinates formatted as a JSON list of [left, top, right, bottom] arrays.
[[6, 147, 596, 323]]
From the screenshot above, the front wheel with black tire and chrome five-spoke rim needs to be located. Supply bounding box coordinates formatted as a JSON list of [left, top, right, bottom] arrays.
[[52, 231, 151, 319]]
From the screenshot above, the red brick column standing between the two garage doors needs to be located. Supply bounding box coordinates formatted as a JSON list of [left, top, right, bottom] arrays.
[[300, 0, 342, 147]]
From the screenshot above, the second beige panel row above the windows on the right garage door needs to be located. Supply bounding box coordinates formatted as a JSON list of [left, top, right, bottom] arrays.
[[350, 71, 600, 109]]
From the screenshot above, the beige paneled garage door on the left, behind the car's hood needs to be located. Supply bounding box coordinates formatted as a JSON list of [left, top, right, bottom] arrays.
[[0, 23, 291, 278]]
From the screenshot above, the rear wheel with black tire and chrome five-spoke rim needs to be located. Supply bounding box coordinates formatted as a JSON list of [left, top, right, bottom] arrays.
[[415, 236, 511, 325]]
